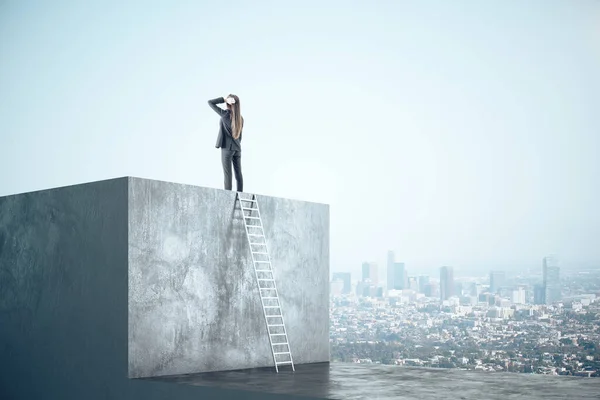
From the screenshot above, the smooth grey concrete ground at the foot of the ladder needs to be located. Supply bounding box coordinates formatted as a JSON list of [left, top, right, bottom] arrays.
[[147, 363, 600, 400]]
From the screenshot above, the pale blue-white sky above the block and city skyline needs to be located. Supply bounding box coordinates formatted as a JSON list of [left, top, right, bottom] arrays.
[[0, 0, 600, 278]]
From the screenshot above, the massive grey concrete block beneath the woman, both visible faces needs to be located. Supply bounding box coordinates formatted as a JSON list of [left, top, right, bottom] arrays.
[[0, 178, 329, 400]]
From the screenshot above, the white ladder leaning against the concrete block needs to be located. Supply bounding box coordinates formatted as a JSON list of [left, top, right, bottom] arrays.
[[237, 193, 296, 373]]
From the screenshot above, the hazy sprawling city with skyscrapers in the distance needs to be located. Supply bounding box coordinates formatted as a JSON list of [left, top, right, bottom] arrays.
[[330, 252, 600, 376]]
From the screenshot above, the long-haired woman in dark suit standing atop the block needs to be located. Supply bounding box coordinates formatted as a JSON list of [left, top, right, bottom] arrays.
[[208, 94, 244, 192]]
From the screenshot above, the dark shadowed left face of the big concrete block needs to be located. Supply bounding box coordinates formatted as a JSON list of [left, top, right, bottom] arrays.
[[0, 179, 127, 399]]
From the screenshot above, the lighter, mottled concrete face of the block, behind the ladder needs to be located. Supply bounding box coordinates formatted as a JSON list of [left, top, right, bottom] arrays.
[[129, 179, 329, 377]]
